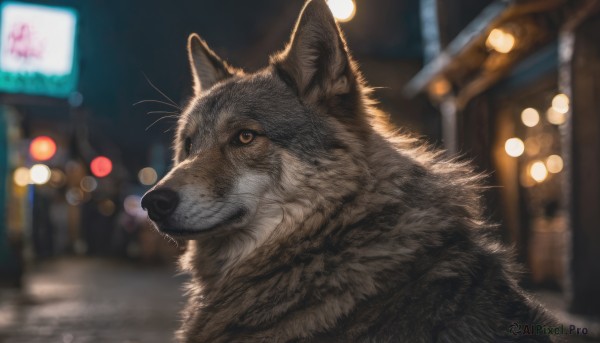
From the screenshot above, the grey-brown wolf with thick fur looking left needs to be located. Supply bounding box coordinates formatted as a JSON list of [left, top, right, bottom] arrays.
[[142, 0, 555, 343]]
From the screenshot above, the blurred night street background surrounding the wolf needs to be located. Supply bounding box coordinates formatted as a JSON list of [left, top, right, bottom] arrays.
[[0, 0, 600, 343]]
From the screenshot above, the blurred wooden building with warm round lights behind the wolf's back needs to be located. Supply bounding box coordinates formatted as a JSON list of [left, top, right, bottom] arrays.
[[405, 0, 600, 315]]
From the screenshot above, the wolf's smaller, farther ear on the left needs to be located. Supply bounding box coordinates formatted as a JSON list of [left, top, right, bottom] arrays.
[[188, 33, 236, 94]]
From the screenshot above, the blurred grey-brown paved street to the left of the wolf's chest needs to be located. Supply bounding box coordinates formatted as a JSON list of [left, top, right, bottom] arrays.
[[0, 259, 186, 343]]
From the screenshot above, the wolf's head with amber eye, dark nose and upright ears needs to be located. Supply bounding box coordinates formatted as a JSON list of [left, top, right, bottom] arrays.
[[142, 0, 371, 264]]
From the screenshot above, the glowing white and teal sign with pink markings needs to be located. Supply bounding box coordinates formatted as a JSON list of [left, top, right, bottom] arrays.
[[0, 2, 77, 97]]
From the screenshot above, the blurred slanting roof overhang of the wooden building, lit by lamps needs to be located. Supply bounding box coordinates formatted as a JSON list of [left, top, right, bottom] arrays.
[[404, 0, 580, 109]]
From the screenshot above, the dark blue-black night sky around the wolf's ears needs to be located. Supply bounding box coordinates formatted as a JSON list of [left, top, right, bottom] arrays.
[[27, 0, 421, 177]]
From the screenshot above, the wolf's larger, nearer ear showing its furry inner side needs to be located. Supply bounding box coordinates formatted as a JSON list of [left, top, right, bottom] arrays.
[[271, 0, 357, 100]]
